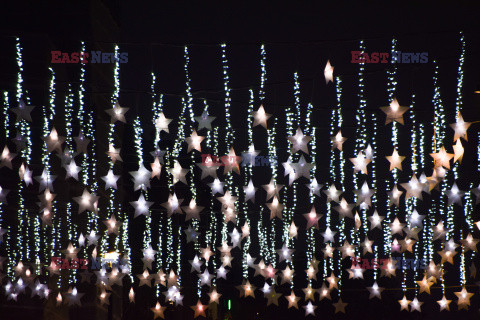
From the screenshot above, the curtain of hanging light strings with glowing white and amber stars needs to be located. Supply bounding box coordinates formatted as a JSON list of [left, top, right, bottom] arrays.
[[0, 33, 480, 319]]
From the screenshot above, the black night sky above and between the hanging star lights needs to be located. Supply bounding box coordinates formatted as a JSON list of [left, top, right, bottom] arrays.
[[0, 1, 480, 319]]
